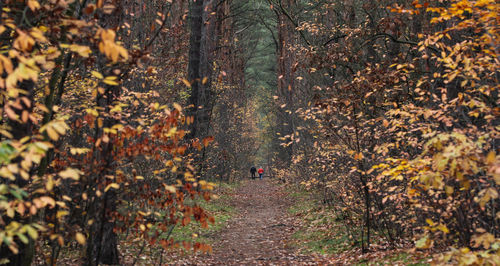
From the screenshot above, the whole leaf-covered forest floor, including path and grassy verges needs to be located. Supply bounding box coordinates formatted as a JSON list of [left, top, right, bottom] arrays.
[[47, 179, 429, 265]]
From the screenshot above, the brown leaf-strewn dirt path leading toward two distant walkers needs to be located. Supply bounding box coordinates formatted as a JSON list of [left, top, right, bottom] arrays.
[[174, 179, 328, 265]]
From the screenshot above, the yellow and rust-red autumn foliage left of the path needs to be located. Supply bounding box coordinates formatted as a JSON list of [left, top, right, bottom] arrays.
[[0, 0, 214, 265]]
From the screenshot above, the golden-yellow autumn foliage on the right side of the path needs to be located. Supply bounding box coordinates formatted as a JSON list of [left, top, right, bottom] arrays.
[[272, 0, 500, 265]]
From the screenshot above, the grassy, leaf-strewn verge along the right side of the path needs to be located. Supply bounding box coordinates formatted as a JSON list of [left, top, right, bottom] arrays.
[[288, 187, 428, 265]]
